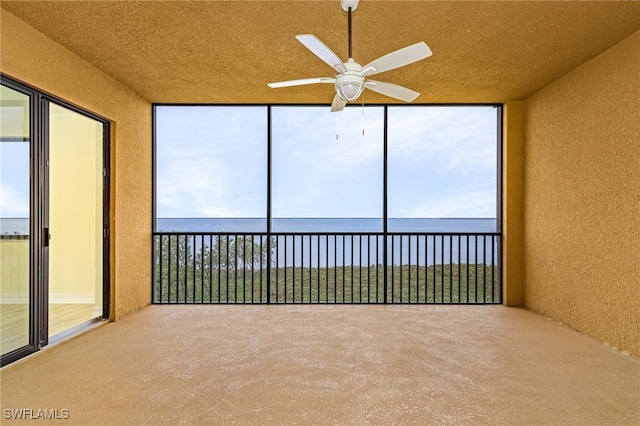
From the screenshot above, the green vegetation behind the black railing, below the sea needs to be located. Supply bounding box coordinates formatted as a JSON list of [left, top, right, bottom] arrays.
[[155, 235, 500, 303]]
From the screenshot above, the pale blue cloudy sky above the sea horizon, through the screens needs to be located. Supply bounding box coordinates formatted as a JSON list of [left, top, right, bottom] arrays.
[[156, 106, 497, 218]]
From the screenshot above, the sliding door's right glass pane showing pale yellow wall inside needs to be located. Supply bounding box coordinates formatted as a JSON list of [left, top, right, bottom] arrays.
[[49, 104, 103, 337]]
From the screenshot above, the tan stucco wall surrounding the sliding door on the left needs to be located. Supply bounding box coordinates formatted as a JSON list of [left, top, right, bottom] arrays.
[[0, 10, 151, 319]]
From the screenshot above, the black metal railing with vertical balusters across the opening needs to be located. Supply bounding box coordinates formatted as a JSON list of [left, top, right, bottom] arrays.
[[153, 232, 502, 304]]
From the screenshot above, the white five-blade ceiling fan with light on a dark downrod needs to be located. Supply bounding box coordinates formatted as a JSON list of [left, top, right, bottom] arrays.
[[268, 0, 432, 112]]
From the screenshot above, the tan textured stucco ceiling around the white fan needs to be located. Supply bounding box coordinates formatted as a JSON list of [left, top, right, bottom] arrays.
[[1, 0, 640, 103]]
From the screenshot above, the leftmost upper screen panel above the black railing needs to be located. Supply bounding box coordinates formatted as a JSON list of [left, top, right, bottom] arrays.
[[156, 106, 267, 232]]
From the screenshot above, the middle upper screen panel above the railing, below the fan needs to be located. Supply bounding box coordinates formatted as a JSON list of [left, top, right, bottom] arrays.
[[272, 107, 384, 232]]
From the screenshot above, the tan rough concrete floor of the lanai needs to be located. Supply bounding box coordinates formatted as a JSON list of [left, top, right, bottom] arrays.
[[0, 305, 640, 425]]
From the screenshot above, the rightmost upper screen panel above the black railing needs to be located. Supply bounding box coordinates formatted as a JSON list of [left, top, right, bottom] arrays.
[[388, 106, 498, 232]]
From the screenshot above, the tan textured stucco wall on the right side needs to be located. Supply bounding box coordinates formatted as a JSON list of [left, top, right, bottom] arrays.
[[524, 32, 640, 356]]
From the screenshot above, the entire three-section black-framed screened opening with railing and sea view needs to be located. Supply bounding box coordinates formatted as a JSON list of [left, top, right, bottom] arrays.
[[153, 105, 502, 304]]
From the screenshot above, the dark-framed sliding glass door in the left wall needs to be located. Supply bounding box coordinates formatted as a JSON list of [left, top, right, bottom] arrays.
[[0, 75, 109, 365]]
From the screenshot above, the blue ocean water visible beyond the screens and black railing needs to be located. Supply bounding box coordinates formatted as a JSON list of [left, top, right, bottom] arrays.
[[157, 218, 500, 267]]
